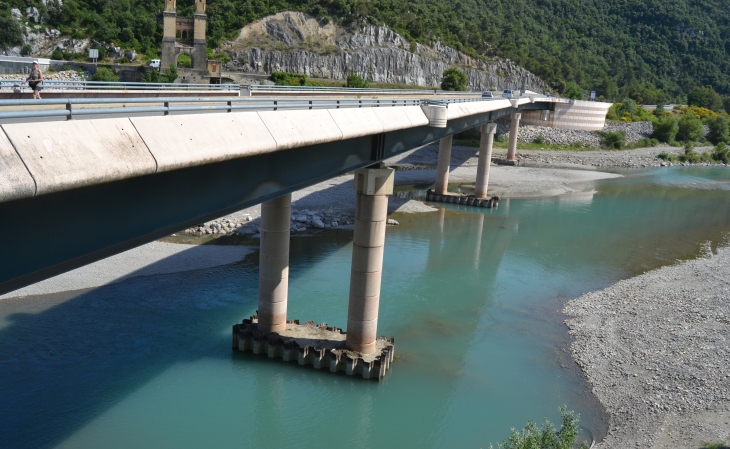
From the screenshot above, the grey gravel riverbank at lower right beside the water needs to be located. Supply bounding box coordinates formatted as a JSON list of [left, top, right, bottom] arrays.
[[564, 246, 730, 449]]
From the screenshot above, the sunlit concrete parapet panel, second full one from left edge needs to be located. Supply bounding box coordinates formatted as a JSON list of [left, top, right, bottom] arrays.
[[130, 112, 277, 173]]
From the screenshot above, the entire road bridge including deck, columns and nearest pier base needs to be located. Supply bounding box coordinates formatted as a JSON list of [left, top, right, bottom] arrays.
[[0, 96, 610, 379]]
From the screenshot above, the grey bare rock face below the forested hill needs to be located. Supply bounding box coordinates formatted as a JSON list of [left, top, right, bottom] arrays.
[[222, 12, 549, 93]]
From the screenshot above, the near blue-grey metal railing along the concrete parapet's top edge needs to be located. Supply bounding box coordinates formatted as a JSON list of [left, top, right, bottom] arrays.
[[0, 97, 422, 120]]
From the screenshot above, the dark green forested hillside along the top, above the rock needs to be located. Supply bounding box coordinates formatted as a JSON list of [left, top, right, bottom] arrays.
[[0, 0, 730, 102]]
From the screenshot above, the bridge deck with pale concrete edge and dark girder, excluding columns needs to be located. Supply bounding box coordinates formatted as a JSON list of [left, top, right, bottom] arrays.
[[0, 98, 607, 293]]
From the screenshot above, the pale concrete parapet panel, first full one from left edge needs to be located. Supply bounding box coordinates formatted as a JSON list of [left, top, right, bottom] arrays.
[[2, 118, 156, 195]]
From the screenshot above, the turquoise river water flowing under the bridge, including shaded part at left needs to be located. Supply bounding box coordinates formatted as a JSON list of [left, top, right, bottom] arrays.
[[0, 167, 730, 448]]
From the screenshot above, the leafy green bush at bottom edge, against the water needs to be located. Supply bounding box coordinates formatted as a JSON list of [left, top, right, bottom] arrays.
[[492, 407, 588, 449]]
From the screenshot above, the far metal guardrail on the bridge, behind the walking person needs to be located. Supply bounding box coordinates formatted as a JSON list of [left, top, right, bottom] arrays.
[[0, 78, 241, 91]]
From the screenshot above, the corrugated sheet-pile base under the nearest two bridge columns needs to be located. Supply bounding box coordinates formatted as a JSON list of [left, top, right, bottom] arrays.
[[232, 316, 395, 380]]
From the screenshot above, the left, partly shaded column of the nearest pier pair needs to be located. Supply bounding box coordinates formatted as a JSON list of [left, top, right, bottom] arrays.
[[258, 193, 291, 332]]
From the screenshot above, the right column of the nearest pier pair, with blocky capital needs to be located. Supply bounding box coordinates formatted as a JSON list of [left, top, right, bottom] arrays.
[[346, 164, 392, 354]]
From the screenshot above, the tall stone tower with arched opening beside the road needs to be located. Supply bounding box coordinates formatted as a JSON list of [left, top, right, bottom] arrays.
[[160, 0, 208, 77]]
